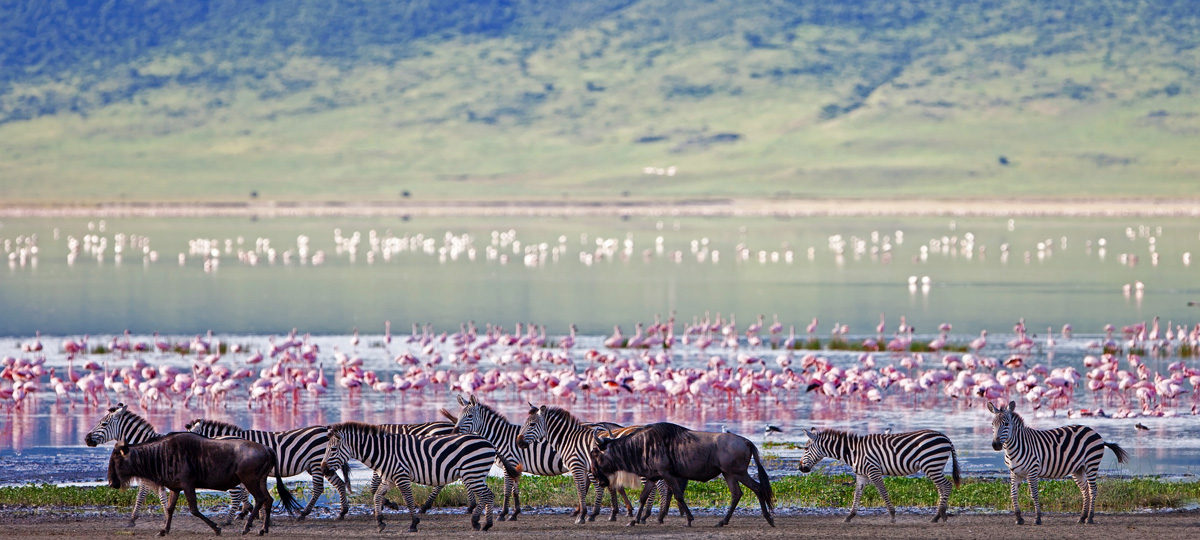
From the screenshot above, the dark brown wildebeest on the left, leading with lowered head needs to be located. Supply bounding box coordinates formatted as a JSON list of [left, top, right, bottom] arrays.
[[108, 432, 300, 536]]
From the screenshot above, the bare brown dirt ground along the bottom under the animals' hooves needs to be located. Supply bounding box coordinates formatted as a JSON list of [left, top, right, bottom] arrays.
[[0, 509, 1200, 540]]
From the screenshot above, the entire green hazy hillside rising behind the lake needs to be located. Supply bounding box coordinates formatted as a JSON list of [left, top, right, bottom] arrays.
[[0, 0, 1200, 204]]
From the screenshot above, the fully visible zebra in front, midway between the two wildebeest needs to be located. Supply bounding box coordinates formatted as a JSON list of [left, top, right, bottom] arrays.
[[320, 422, 520, 533]]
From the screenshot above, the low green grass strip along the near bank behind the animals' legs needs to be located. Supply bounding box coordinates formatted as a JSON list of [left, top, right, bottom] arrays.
[[0, 474, 1200, 512]]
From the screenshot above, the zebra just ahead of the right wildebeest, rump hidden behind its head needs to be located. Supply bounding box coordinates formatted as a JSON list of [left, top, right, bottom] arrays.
[[518, 404, 617, 523]]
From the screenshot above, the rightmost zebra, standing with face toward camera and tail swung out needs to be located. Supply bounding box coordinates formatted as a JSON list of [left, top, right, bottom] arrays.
[[988, 401, 1129, 524]]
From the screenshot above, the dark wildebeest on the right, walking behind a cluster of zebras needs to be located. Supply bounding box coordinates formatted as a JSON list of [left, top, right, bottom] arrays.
[[592, 422, 775, 527]]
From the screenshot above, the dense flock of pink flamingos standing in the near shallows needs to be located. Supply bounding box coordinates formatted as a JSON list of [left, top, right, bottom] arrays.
[[0, 313, 1200, 416]]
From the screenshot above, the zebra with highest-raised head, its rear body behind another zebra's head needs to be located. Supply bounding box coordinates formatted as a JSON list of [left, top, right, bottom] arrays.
[[446, 396, 568, 521]]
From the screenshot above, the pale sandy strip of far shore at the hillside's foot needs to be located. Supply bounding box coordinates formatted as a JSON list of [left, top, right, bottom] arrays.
[[0, 198, 1200, 218]]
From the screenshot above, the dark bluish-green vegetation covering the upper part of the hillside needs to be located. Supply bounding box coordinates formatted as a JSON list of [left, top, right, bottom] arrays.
[[0, 0, 1200, 122]]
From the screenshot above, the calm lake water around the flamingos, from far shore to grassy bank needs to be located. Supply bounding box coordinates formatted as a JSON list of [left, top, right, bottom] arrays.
[[0, 214, 1200, 484]]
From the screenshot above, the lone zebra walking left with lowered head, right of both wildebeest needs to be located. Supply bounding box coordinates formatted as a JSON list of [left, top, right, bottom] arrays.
[[800, 427, 962, 523]]
